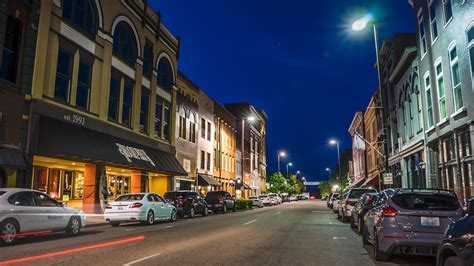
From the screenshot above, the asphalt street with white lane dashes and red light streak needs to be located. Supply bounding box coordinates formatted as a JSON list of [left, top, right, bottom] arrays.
[[0, 200, 435, 266]]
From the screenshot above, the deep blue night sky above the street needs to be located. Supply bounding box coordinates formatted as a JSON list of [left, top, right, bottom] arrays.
[[149, 0, 415, 180]]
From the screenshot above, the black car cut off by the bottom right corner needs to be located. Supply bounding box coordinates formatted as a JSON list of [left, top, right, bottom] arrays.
[[436, 199, 474, 266]]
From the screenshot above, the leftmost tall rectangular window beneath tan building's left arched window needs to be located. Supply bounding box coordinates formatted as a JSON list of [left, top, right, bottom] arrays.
[[54, 48, 72, 103]]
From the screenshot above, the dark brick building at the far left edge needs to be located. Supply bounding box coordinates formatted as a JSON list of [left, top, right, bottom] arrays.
[[0, 0, 40, 187]]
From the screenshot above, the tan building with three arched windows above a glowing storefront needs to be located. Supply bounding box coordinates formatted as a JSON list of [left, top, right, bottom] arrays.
[[27, 0, 187, 213]]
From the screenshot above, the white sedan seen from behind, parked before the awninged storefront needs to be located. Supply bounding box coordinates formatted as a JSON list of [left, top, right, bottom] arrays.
[[104, 193, 177, 226]]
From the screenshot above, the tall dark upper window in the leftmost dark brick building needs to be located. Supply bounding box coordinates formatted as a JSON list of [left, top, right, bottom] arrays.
[[0, 17, 22, 83]]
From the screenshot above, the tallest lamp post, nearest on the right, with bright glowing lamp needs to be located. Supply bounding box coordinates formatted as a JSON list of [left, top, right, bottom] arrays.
[[352, 14, 388, 190]]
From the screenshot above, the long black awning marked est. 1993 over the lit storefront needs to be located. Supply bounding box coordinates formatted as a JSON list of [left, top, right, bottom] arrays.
[[35, 117, 187, 175]]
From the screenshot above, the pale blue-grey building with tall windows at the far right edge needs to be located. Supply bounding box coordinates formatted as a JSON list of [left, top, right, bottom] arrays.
[[409, 0, 474, 200]]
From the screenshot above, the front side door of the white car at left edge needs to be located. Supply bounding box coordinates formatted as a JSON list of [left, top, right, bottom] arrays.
[[34, 192, 70, 229]]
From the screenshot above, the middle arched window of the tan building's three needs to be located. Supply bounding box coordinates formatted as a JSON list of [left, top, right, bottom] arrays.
[[113, 21, 137, 65]]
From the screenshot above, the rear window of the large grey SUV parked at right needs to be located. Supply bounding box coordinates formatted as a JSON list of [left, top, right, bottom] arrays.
[[392, 193, 460, 211]]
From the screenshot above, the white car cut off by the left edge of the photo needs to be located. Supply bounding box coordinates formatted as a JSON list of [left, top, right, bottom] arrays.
[[0, 188, 86, 245]]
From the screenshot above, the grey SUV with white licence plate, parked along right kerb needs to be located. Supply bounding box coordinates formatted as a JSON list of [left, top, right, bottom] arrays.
[[362, 189, 463, 261]]
